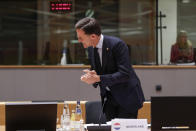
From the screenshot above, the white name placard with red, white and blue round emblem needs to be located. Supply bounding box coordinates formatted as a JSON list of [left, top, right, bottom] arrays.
[[111, 119, 148, 131]]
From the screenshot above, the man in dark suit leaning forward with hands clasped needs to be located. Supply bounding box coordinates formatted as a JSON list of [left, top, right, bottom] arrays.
[[75, 18, 145, 121]]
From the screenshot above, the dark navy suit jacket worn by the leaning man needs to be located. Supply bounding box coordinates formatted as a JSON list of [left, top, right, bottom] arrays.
[[88, 36, 145, 112]]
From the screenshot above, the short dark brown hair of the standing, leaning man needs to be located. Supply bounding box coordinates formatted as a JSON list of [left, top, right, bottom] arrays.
[[75, 17, 101, 36]]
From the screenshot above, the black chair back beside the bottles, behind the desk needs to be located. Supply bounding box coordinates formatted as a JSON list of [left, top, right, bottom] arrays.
[[85, 101, 106, 124]]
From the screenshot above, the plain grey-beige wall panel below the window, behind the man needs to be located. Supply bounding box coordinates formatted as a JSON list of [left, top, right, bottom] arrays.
[[0, 68, 196, 101]]
